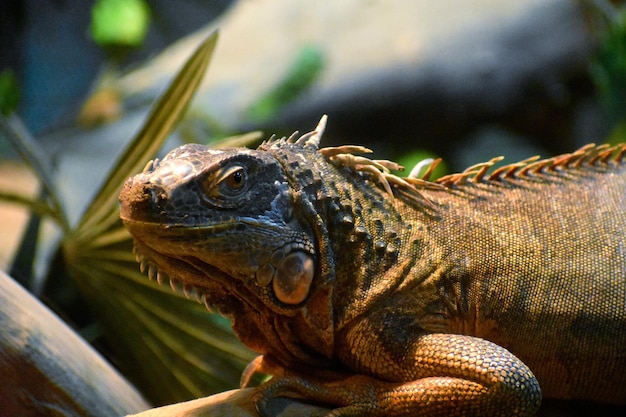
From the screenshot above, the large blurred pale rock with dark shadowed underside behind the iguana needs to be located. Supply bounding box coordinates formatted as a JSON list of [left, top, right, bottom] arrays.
[[109, 0, 606, 167]]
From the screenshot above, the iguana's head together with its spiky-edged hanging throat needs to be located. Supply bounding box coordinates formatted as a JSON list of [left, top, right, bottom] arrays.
[[120, 118, 346, 362]]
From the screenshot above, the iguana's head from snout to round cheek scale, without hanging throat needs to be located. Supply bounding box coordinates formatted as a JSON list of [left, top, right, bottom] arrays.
[[120, 144, 322, 302]]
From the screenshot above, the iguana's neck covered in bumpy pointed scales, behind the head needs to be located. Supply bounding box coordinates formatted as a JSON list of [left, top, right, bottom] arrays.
[[266, 143, 442, 332]]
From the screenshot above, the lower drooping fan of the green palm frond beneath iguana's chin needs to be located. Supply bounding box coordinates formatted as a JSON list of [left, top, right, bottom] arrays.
[[67, 234, 254, 404]]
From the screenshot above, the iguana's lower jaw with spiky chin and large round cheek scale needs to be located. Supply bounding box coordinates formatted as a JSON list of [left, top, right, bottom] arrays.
[[124, 214, 315, 310]]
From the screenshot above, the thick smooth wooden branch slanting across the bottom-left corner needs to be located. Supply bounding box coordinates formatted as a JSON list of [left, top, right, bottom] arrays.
[[0, 271, 149, 417]]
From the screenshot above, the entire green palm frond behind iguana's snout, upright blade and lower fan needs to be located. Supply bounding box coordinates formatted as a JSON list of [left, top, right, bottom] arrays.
[[58, 30, 253, 403]]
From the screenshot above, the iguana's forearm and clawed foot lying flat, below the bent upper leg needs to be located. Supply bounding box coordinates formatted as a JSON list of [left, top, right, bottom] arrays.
[[254, 375, 541, 417]]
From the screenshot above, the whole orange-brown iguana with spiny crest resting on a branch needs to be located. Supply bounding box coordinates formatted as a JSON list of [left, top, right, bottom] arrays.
[[120, 117, 626, 416]]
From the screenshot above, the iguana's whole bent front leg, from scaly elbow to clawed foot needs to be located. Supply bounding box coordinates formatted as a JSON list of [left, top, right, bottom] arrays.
[[251, 333, 541, 417]]
